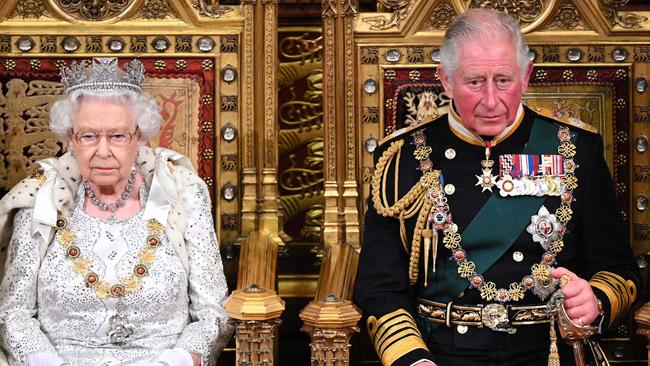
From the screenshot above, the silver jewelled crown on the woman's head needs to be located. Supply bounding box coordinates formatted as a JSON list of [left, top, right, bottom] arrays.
[[61, 57, 144, 93]]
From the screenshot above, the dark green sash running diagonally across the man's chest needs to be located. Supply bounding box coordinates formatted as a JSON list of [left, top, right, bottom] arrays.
[[418, 119, 559, 302]]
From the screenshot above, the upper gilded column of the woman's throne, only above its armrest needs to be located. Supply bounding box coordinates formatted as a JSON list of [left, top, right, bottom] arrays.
[[242, 0, 282, 245]]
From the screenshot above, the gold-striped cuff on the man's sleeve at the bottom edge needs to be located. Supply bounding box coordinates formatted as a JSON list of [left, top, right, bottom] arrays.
[[367, 309, 429, 365]]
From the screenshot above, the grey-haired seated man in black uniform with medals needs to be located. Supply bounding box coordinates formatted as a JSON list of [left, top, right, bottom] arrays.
[[355, 9, 639, 366]]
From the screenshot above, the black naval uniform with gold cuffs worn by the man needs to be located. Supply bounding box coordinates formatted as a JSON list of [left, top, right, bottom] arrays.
[[354, 107, 638, 366]]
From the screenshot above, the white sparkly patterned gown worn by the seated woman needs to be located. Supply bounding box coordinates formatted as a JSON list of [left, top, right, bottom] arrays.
[[0, 185, 230, 366]]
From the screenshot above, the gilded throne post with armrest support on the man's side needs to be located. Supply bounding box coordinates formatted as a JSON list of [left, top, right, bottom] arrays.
[[300, 0, 361, 366]]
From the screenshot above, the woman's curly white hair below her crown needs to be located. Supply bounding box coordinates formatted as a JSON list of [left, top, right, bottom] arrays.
[[50, 89, 162, 144]]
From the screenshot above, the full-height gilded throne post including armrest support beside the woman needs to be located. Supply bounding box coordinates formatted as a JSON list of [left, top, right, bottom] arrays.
[[224, 0, 284, 365]]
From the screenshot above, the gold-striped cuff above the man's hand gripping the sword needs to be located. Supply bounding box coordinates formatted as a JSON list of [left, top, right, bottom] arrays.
[[589, 271, 636, 326]]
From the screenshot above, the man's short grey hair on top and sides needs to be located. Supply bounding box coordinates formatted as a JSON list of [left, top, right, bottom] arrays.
[[440, 9, 530, 78]]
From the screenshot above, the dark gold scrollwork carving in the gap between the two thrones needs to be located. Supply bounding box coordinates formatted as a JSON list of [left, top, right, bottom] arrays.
[[278, 27, 323, 241]]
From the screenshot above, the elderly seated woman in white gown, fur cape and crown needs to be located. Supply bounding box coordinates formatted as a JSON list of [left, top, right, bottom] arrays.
[[0, 58, 230, 366]]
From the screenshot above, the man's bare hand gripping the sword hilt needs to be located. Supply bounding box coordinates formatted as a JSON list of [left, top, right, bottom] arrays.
[[551, 267, 599, 325]]
